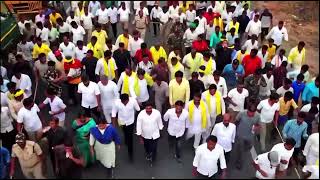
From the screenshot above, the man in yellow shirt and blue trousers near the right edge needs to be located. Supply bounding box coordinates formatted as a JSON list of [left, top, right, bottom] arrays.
[[278, 91, 298, 131]]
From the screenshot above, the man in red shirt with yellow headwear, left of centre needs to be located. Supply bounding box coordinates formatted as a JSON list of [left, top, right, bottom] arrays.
[[63, 56, 82, 104]]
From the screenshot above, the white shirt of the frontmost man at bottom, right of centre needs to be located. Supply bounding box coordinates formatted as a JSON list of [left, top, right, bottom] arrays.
[[193, 143, 227, 177]]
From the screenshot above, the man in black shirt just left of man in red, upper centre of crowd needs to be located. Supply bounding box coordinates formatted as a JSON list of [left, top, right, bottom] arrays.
[[113, 42, 132, 74]]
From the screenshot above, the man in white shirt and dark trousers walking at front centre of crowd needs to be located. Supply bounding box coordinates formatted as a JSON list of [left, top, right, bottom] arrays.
[[137, 103, 163, 163]]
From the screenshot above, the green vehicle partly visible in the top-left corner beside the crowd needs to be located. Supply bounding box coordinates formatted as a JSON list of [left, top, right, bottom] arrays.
[[0, 1, 20, 51]]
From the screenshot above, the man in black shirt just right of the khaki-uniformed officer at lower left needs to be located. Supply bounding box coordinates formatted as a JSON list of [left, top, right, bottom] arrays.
[[42, 117, 66, 174]]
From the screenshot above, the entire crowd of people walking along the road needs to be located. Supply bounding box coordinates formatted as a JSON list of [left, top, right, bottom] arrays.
[[0, 1, 320, 179]]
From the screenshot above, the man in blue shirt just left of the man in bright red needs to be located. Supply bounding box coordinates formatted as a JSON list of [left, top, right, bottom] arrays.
[[222, 59, 244, 89]]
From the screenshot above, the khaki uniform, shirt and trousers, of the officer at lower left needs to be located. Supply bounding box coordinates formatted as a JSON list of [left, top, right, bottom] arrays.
[[11, 140, 45, 179]]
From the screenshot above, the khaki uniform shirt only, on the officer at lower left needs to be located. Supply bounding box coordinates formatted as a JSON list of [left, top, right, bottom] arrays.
[[11, 140, 42, 168]]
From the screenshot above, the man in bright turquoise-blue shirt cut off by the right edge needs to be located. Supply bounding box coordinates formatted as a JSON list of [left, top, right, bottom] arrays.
[[302, 75, 320, 104]]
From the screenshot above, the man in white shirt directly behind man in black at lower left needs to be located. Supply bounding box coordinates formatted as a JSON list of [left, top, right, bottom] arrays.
[[39, 88, 67, 127]]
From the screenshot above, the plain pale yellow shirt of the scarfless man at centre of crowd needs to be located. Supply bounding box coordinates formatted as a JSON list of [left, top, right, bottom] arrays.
[[169, 78, 190, 105]]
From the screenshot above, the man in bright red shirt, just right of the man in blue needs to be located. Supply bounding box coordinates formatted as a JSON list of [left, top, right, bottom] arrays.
[[242, 49, 262, 77]]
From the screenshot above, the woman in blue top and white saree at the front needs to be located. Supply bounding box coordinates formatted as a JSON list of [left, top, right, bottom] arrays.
[[90, 117, 120, 178]]
